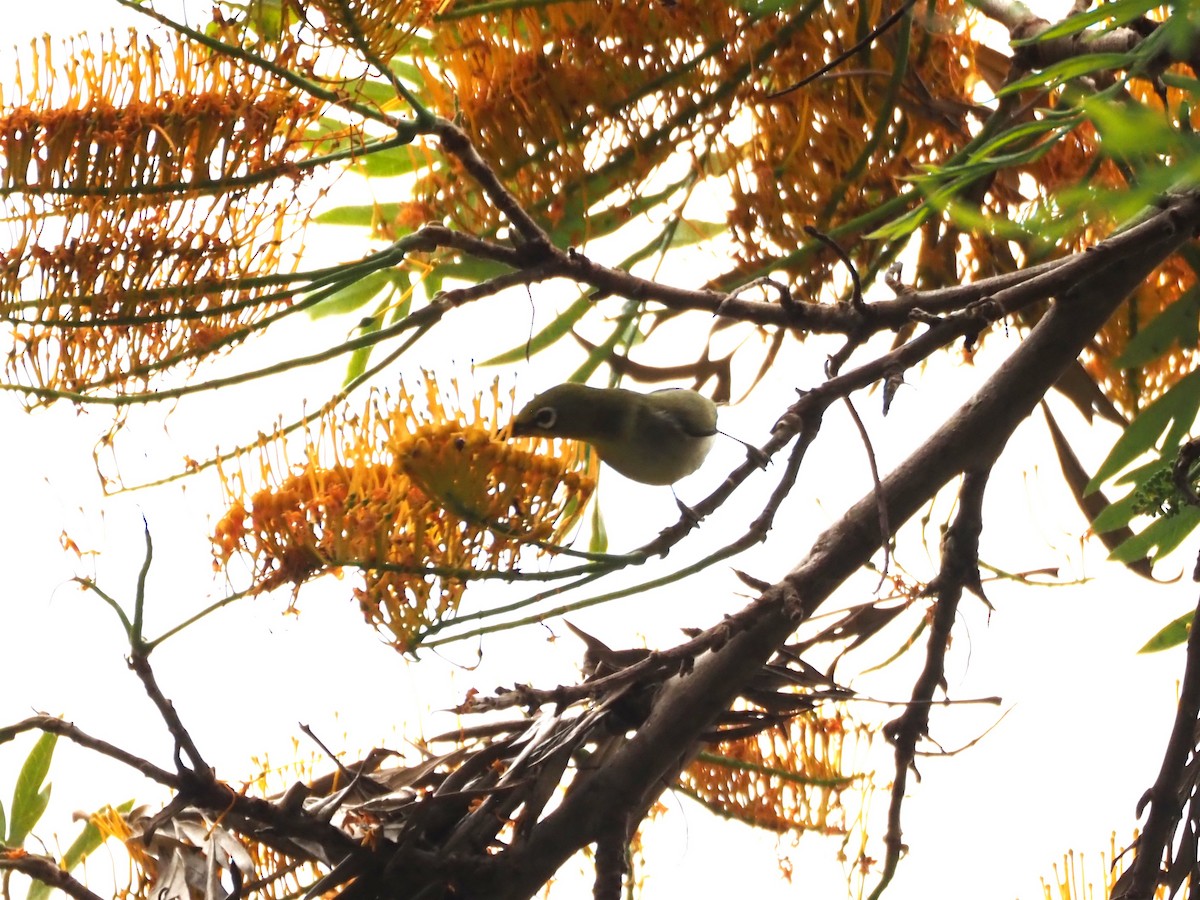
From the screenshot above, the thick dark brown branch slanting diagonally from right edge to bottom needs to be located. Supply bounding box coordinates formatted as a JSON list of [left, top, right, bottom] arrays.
[[468, 197, 1200, 900]]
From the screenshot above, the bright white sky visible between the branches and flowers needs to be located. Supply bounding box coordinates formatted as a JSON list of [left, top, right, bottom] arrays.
[[0, 0, 1195, 900]]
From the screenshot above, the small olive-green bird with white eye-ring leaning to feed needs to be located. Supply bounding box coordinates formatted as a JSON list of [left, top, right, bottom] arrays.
[[510, 384, 719, 485]]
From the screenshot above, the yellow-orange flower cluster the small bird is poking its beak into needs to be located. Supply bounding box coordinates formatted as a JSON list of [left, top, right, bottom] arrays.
[[214, 374, 596, 650]]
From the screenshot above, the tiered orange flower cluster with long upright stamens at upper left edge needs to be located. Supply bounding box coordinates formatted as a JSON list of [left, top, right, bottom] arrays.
[[0, 35, 318, 400]]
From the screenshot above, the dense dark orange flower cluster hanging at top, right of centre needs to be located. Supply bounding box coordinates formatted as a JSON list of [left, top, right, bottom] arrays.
[[728, 0, 979, 286]]
